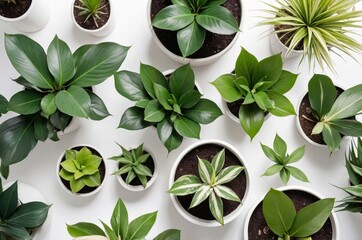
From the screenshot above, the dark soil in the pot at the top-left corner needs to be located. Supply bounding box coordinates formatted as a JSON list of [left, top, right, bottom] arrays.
[[0, 0, 32, 18]]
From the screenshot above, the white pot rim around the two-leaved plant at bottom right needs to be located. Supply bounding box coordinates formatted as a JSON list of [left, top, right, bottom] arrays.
[[243, 186, 340, 240]]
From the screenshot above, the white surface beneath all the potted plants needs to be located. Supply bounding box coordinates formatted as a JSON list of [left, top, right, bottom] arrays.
[[0, 0, 362, 240]]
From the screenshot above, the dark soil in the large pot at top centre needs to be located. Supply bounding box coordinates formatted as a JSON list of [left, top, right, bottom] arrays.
[[151, 0, 242, 58]]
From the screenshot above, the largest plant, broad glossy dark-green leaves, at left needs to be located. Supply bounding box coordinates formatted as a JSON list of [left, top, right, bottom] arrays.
[[0, 34, 128, 176]]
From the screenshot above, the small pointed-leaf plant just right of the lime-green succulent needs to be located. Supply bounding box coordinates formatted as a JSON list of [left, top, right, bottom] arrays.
[[110, 144, 153, 188]]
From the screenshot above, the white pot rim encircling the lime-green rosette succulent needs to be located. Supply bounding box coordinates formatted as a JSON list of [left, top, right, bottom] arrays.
[[55, 144, 108, 197]]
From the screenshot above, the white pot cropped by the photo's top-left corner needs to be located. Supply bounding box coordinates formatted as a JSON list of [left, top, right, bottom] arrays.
[[0, 0, 50, 32]]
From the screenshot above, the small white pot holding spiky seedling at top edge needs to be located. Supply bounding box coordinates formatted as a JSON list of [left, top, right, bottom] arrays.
[[71, 0, 117, 37]]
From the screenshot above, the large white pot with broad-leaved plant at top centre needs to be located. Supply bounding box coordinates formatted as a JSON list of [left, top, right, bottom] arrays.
[[147, 0, 244, 66]]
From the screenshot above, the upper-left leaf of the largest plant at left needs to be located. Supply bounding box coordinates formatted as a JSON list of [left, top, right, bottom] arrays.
[[5, 34, 54, 89]]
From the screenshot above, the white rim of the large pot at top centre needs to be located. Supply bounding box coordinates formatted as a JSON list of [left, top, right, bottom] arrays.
[[147, 0, 245, 66]]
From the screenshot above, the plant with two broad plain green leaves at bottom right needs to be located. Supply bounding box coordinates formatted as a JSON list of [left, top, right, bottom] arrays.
[[263, 189, 334, 240]]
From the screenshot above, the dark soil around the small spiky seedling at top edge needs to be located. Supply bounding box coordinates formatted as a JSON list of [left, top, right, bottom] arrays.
[[74, 0, 111, 30]]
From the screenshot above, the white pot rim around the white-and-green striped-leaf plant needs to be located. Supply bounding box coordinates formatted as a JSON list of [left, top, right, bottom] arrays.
[[169, 139, 250, 227]]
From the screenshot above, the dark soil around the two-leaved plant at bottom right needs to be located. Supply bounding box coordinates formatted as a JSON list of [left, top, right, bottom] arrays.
[[248, 190, 333, 240]]
